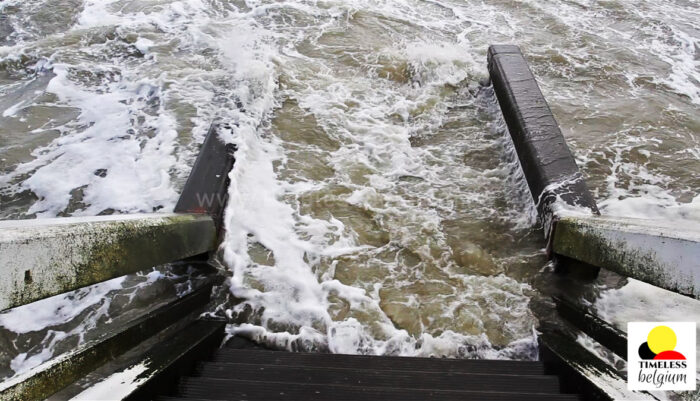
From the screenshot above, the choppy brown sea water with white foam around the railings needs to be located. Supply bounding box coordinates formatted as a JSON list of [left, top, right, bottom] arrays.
[[0, 0, 700, 384]]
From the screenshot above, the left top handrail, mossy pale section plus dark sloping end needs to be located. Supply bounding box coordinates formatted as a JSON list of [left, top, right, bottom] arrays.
[[0, 124, 235, 311]]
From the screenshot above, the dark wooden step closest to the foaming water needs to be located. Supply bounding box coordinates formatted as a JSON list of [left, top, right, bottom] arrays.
[[212, 348, 544, 375]]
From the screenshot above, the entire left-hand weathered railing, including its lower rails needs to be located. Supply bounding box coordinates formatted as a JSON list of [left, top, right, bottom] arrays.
[[0, 125, 234, 400]]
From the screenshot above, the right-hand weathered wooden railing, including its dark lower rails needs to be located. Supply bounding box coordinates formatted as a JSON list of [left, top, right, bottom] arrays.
[[488, 45, 700, 399]]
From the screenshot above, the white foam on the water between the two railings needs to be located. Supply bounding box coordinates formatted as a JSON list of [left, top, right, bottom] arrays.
[[216, 0, 536, 358]]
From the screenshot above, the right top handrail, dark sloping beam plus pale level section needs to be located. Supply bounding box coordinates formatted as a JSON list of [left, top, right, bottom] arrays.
[[488, 45, 700, 298]]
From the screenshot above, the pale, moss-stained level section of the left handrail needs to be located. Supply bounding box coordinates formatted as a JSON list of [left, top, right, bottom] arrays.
[[0, 214, 216, 310]]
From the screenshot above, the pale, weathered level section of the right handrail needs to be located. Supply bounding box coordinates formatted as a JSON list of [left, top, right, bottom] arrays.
[[553, 217, 700, 298]]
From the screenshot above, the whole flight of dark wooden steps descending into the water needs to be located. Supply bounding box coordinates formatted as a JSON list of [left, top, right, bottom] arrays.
[[156, 337, 581, 401]]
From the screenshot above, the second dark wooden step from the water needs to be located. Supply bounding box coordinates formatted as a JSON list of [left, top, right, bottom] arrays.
[[197, 363, 560, 393]]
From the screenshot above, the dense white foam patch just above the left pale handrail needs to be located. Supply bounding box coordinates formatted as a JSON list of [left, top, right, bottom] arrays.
[[3, 64, 177, 217]]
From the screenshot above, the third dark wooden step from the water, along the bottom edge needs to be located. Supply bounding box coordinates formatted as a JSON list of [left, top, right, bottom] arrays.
[[179, 377, 580, 401]]
